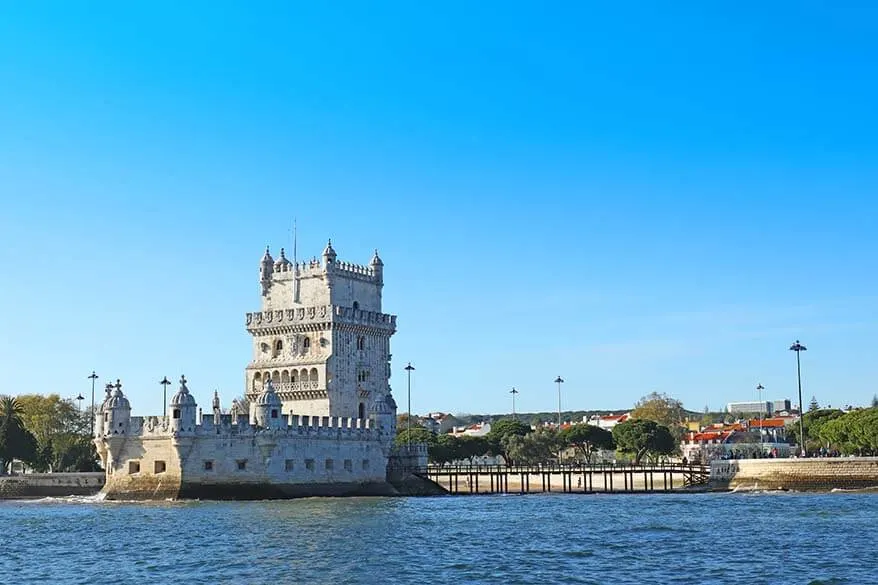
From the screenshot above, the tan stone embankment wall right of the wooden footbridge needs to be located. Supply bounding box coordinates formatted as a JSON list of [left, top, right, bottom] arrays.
[[710, 457, 878, 491]]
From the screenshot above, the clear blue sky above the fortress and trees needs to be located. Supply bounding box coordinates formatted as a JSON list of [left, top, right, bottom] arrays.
[[0, 2, 878, 414]]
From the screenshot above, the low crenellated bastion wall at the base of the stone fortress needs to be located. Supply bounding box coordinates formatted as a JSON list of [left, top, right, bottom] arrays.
[[104, 415, 392, 500]]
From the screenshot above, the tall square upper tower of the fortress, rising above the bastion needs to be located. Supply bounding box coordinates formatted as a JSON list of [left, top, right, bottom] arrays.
[[245, 242, 396, 420]]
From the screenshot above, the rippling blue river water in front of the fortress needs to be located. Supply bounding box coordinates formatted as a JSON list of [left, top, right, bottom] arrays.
[[0, 493, 878, 585]]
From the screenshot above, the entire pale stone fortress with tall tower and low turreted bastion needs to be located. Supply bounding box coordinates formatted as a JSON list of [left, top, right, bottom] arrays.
[[95, 242, 426, 499]]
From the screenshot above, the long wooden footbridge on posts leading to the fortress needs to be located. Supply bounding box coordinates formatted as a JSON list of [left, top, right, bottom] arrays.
[[413, 463, 710, 495]]
